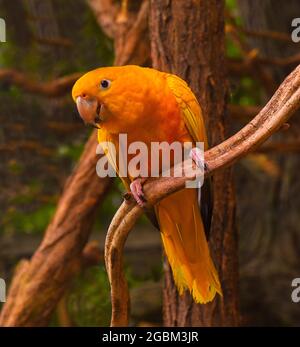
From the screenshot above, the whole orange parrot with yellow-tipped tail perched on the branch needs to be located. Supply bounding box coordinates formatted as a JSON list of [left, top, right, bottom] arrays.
[[72, 65, 222, 303]]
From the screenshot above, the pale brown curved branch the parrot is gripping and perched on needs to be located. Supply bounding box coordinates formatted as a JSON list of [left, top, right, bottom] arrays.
[[105, 65, 300, 326]]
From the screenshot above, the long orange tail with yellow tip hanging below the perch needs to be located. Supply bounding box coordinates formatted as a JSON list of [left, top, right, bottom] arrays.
[[155, 189, 222, 304]]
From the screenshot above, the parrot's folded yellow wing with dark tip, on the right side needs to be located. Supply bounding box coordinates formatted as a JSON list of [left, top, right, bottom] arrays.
[[167, 74, 213, 237]]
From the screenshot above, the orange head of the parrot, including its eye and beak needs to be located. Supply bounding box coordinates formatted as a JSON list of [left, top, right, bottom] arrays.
[[72, 65, 161, 133]]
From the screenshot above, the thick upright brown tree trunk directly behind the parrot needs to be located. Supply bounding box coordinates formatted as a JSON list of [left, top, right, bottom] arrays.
[[150, 0, 239, 326]]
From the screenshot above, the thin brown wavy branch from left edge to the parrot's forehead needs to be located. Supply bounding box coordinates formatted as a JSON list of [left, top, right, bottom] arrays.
[[0, 69, 82, 97]]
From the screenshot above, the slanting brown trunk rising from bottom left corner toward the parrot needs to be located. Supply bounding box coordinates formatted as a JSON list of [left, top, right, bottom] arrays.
[[0, 132, 111, 326]]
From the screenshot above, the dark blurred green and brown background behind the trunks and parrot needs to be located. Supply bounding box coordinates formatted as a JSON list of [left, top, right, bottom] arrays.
[[0, 0, 300, 326]]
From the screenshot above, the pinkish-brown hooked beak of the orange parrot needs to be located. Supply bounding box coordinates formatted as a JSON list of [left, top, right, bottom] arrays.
[[76, 95, 103, 128]]
